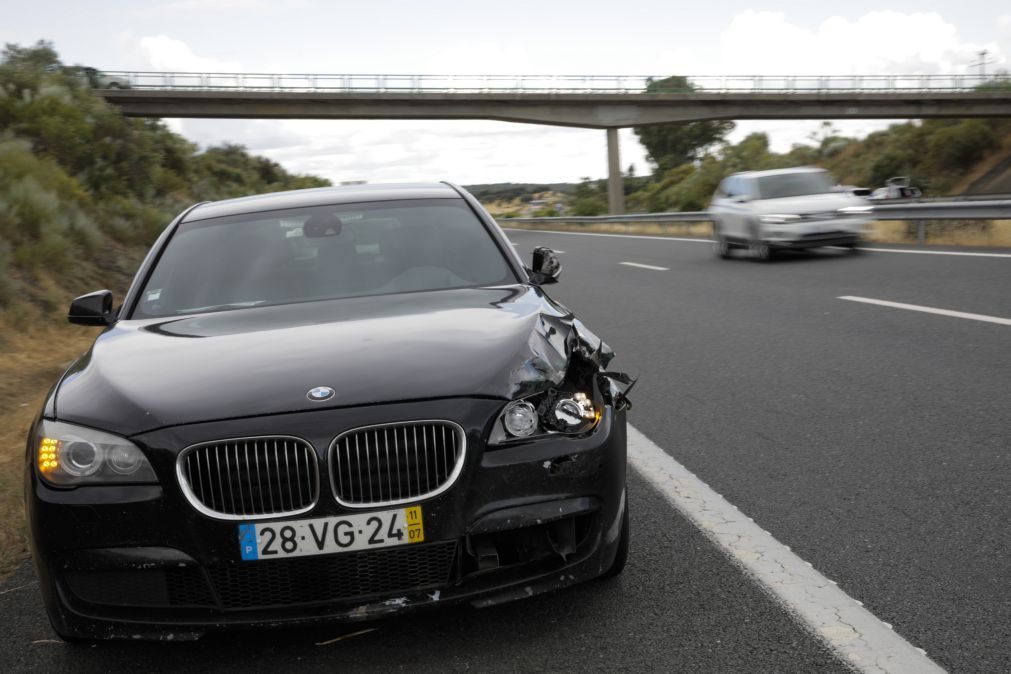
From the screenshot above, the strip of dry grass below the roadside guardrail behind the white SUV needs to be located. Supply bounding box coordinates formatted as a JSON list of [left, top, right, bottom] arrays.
[[498, 219, 1011, 248]]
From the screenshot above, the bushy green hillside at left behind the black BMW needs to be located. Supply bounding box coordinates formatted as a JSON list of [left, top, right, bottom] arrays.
[[0, 42, 329, 327]]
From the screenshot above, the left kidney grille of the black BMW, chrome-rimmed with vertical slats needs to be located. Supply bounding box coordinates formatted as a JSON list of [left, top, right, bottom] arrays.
[[176, 437, 319, 519]]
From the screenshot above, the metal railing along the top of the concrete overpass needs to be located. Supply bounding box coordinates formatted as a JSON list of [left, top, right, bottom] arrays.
[[103, 71, 1007, 94]]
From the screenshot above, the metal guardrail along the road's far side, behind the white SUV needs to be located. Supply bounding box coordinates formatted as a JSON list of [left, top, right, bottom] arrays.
[[498, 199, 1011, 223]]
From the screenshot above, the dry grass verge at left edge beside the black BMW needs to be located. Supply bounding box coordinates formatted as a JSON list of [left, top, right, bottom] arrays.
[[0, 321, 96, 580]]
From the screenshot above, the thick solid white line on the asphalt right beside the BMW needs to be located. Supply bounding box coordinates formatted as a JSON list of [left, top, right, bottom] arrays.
[[628, 426, 944, 674]]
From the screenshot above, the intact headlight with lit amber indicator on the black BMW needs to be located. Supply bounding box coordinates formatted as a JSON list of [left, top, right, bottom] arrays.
[[35, 420, 158, 487]]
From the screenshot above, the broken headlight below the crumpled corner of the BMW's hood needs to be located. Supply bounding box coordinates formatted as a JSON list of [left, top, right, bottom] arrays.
[[488, 388, 601, 445]]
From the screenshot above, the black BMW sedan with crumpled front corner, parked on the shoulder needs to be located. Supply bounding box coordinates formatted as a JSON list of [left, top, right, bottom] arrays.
[[25, 184, 631, 640]]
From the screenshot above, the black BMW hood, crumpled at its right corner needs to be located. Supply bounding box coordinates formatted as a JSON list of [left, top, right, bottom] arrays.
[[56, 285, 598, 436]]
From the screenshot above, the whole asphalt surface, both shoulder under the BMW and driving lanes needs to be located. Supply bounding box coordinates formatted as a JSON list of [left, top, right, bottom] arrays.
[[0, 231, 1011, 672]]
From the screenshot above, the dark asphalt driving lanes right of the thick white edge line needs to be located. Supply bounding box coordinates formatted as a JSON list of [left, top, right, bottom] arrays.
[[509, 230, 1011, 672]]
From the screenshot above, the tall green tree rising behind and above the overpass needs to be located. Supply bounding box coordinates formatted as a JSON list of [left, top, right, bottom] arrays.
[[633, 75, 734, 170]]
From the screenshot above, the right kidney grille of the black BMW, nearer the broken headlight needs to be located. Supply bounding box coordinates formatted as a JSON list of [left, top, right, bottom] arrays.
[[329, 420, 466, 507]]
